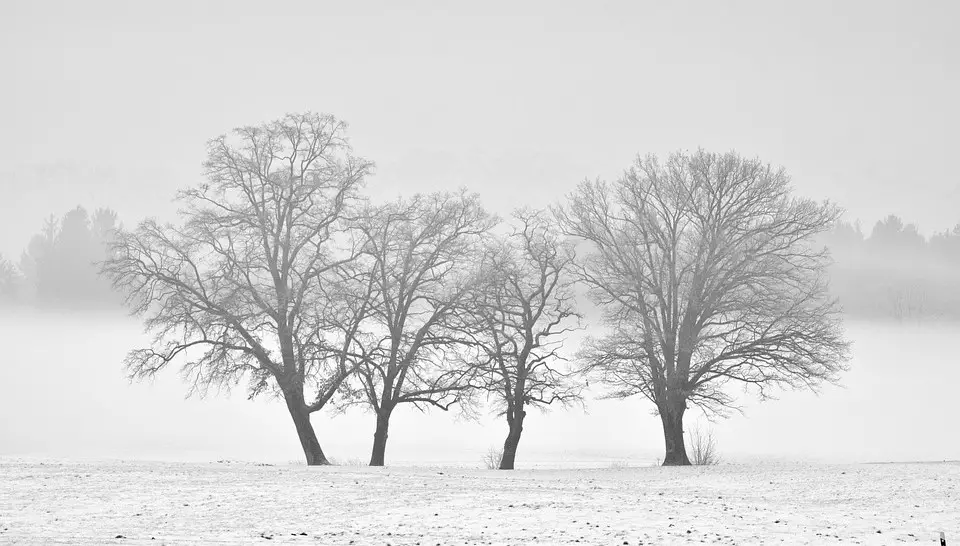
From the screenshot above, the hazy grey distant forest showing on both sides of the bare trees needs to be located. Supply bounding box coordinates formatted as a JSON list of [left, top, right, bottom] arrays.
[[0, 206, 960, 321]]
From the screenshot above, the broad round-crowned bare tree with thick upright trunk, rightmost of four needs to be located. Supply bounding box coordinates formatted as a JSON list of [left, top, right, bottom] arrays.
[[556, 150, 848, 465]]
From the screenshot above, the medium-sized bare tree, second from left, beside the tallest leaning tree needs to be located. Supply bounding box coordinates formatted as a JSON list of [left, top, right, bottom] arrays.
[[348, 188, 496, 466]]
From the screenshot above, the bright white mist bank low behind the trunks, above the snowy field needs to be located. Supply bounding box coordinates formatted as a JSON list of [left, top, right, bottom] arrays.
[[0, 308, 960, 467]]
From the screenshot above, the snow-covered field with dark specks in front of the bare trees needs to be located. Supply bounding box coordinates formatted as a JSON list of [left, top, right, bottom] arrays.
[[0, 459, 960, 546]]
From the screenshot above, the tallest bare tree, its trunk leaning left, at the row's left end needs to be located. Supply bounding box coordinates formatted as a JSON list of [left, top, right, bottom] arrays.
[[102, 113, 372, 465]]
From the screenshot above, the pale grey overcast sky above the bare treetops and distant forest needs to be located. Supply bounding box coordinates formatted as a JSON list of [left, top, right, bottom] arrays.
[[0, 0, 960, 256]]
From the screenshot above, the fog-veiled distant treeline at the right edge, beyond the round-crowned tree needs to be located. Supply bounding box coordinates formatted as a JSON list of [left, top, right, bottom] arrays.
[[824, 215, 960, 321]]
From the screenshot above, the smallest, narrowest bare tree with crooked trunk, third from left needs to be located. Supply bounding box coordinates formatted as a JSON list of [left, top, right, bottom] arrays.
[[475, 209, 581, 470]]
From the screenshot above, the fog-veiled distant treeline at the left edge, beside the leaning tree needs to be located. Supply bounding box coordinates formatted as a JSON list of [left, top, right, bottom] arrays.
[[0, 206, 119, 309]]
